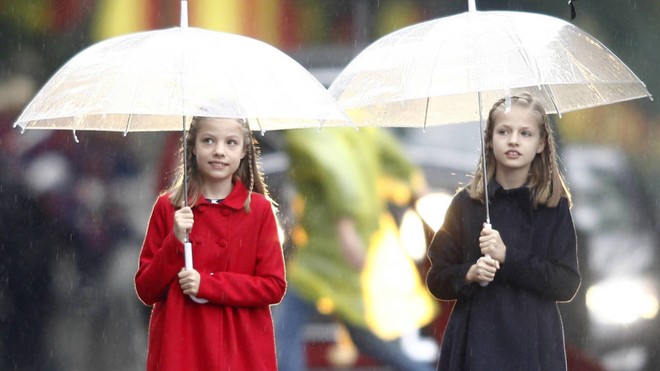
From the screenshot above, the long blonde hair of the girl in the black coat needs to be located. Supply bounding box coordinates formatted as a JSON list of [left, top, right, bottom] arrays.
[[468, 93, 572, 207]]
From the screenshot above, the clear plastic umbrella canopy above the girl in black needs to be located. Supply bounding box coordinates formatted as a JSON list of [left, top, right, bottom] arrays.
[[329, 6, 650, 127]]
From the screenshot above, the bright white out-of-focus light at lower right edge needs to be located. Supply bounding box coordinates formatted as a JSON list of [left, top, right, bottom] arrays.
[[587, 278, 658, 325]]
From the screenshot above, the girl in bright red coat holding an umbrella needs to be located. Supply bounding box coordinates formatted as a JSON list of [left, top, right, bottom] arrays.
[[135, 117, 286, 371]]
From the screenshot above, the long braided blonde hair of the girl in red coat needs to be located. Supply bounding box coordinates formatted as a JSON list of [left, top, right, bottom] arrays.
[[166, 116, 269, 213]]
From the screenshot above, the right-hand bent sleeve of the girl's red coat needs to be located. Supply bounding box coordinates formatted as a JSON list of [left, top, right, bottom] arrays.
[[197, 204, 286, 307]]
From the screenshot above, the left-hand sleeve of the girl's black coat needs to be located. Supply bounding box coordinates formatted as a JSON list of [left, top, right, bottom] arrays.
[[426, 194, 475, 300]]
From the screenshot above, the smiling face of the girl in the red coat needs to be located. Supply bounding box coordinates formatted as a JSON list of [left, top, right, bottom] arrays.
[[192, 117, 246, 189]]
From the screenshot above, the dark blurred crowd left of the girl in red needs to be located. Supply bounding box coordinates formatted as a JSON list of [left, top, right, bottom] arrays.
[[0, 75, 159, 371]]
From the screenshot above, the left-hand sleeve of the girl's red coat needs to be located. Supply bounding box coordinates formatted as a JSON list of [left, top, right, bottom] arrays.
[[135, 196, 184, 305]]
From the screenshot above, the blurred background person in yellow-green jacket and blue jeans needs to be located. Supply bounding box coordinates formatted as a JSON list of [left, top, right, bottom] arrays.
[[275, 128, 435, 371]]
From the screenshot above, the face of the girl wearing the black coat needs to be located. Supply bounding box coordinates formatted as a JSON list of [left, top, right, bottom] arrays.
[[492, 105, 545, 178]]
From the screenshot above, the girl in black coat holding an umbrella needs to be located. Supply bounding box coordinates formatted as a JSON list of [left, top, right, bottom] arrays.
[[426, 94, 580, 371]]
